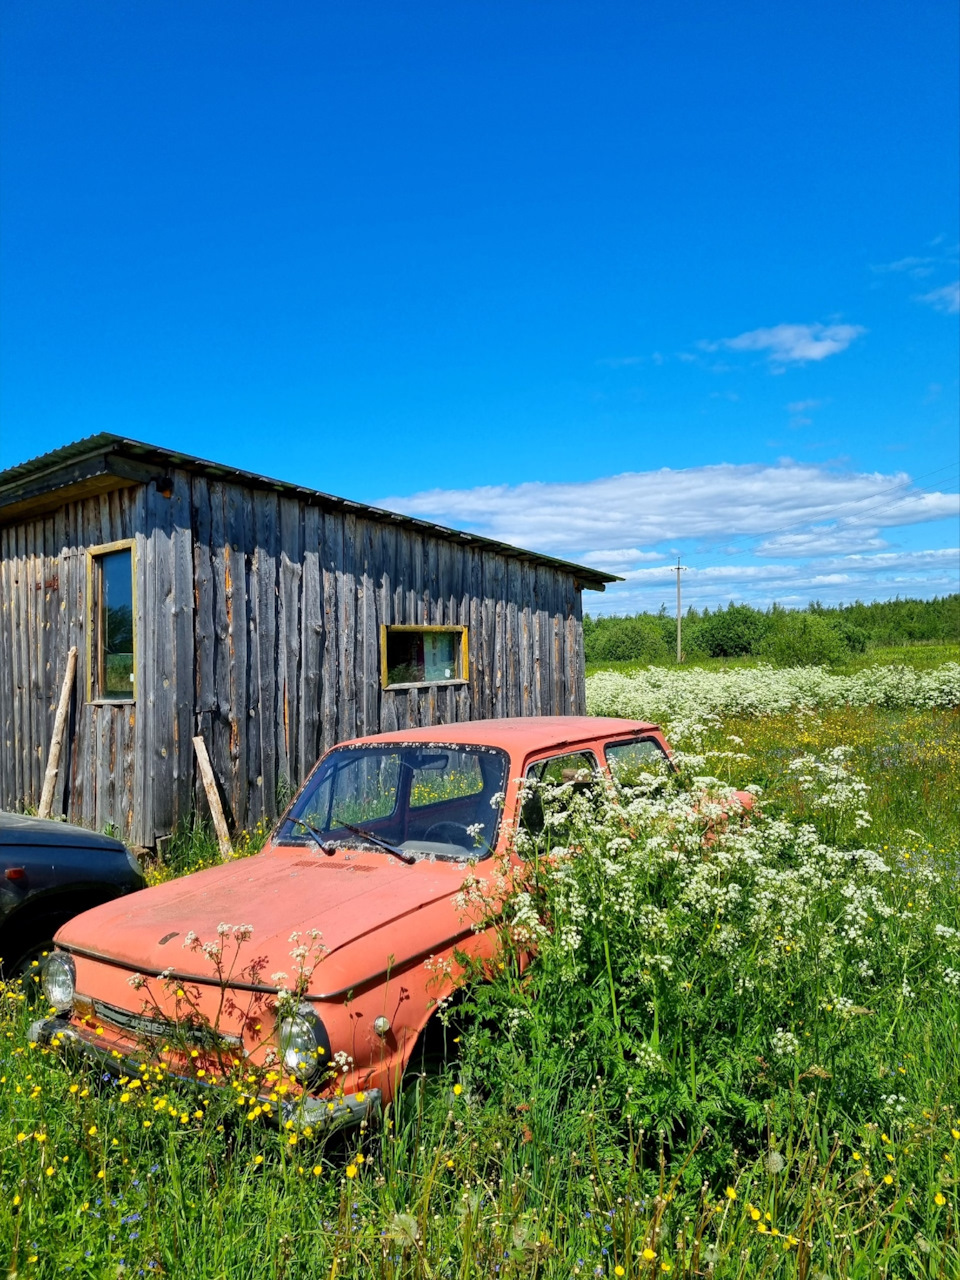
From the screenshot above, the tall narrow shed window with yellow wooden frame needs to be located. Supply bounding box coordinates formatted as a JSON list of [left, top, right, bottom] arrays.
[[90, 544, 136, 703]]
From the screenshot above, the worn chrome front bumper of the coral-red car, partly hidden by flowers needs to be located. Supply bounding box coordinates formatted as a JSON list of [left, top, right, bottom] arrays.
[[27, 1018, 381, 1132]]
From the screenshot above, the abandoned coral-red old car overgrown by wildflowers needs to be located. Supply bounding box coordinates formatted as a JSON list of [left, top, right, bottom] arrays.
[[32, 717, 732, 1124]]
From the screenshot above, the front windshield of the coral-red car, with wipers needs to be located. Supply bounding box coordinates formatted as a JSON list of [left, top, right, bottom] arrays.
[[275, 742, 508, 861]]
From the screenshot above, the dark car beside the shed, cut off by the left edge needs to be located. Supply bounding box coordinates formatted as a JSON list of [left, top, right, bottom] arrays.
[[0, 813, 146, 975]]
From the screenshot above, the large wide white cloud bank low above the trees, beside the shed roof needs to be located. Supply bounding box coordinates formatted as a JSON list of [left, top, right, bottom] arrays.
[[381, 460, 960, 612]]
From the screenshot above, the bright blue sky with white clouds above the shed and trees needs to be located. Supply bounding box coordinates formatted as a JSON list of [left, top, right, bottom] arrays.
[[0, 0, 960, 612]]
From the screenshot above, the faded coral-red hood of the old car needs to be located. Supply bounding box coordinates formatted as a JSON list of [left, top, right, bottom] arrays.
[[56, 846, 483, 995]]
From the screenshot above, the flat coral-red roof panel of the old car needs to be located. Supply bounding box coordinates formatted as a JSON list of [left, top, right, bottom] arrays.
[[339, 716, 658, 754]]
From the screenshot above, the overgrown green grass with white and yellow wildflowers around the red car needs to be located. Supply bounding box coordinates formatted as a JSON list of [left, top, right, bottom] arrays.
[[0, 708, 960, 1280]]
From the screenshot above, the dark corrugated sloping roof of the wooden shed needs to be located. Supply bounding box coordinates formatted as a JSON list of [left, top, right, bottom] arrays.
[[0, 431, 622, 591]]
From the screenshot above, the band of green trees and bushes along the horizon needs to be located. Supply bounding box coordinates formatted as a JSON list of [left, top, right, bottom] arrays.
[[584, 593, 960, 666]]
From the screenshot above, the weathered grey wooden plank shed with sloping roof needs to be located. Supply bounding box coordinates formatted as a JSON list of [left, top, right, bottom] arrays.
[[0, 434, 614, 846]]
